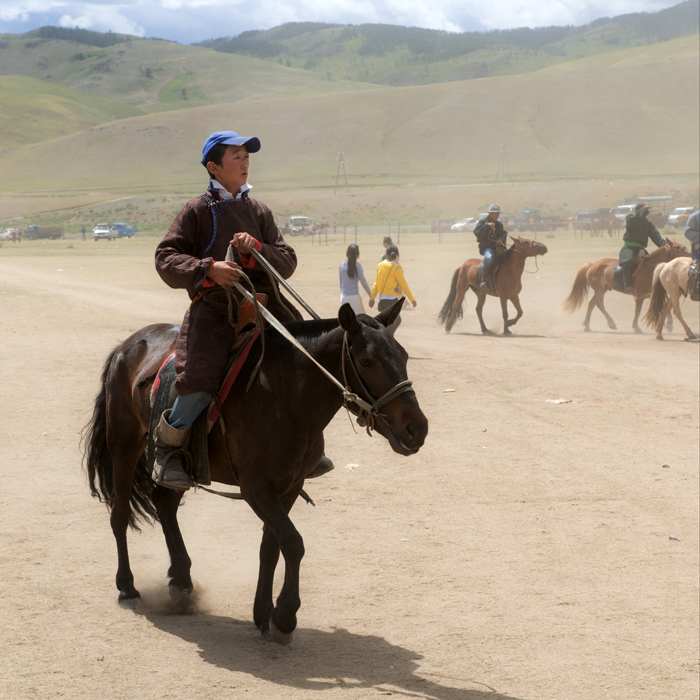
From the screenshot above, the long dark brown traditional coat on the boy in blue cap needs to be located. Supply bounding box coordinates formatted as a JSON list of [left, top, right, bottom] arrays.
[[156, 192, 300, 394]]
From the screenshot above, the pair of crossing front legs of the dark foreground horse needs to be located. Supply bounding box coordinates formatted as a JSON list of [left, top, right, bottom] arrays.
[[246, 485, 304, 644]]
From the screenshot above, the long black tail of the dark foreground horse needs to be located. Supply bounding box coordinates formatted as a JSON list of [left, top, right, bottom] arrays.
[[81, 347, 158, 530]]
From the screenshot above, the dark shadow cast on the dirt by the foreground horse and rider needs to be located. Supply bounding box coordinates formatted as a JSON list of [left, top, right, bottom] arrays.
[[134, 606, 519, 700]]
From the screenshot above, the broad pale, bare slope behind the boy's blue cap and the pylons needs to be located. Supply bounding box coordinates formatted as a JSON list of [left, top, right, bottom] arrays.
[[0, 38, 699, 190]]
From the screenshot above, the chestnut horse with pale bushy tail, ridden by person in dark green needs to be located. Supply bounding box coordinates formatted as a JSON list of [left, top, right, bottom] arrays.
[[563, 238, 690, 333]]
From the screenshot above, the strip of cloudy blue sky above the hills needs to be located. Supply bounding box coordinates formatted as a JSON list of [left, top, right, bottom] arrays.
[[0, 0, 678, 44]]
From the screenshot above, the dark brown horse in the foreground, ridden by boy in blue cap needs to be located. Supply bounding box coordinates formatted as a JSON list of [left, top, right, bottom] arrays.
[[85, 302, 428, 644]]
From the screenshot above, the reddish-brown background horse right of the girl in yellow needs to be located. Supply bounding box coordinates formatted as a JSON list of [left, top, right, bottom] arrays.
[[438, 238, 547, 335]]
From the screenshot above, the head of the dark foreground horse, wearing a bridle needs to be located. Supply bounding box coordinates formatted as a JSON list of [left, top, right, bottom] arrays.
[[338, 299, 428, 455]]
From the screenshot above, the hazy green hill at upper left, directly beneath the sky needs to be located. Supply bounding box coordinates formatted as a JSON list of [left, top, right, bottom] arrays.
[[0, 35, 374, 111]]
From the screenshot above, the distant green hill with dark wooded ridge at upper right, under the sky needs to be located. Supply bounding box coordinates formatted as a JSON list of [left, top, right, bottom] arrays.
[[201, 0, 700, 85]]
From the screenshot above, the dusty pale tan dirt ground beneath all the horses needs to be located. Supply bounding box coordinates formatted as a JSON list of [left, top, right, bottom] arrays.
[[0, 232, 700, 700]]
